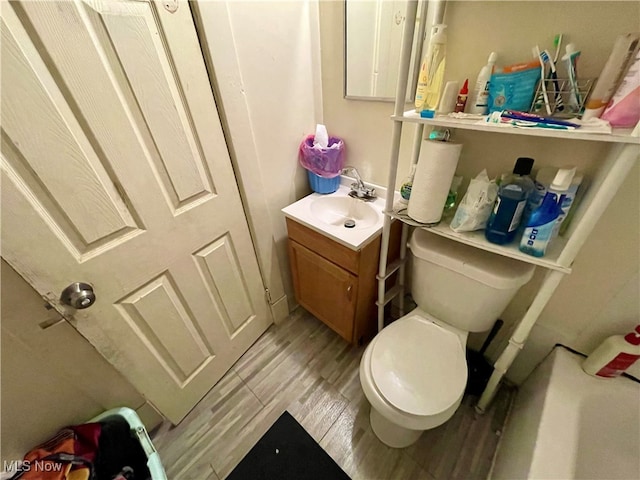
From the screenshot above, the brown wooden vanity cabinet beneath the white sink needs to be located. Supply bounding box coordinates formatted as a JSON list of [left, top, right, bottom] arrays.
[[286, 218, 401, 344]]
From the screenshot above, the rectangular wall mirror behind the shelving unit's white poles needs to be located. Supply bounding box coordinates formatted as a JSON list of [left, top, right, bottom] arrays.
[[344, 0, 428, 102]]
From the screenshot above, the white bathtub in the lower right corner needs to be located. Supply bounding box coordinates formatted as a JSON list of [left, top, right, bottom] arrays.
[[489, 347, 640, 480]]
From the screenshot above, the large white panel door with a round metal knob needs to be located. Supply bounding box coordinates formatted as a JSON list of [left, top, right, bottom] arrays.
[[1, 0, 271, 423]]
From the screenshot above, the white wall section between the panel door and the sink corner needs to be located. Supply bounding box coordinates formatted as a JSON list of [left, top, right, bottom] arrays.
[[196, 0, 322, 314]]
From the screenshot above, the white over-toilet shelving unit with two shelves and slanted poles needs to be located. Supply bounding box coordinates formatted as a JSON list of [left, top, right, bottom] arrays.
[[377, 0, 640, 411]]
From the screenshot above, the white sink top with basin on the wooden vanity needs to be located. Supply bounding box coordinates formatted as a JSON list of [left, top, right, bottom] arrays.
[[282, 177, 386, 250]]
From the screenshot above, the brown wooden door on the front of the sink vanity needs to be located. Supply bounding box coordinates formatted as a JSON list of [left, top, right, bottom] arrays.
[[289, 240, 358, 342]]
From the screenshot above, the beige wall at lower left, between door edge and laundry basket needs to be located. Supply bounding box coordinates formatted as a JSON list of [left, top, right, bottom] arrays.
[[0, 259, 162, 462]]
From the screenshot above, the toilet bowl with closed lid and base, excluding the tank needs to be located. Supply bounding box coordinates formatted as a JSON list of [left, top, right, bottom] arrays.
[[360, 308, 467, 448]]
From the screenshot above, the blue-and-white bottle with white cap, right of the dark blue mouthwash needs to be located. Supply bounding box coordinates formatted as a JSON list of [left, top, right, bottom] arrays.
[[520, 168, 576, 257]]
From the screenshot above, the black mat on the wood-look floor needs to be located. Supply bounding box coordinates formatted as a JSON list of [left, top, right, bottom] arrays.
[[227, 412, 349, 480]]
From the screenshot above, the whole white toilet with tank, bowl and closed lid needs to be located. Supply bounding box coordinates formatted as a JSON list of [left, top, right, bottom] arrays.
[[360, 230, 534, 448]]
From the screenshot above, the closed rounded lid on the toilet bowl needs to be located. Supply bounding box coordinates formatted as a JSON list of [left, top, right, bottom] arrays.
[[371, 316, 467, 415]]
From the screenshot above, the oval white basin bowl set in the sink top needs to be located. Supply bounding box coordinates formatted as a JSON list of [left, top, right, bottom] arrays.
[[310, 196, 380, 228]]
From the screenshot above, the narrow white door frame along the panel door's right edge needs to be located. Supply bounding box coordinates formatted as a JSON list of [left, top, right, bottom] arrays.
[[189, 0, 289, 324]]
